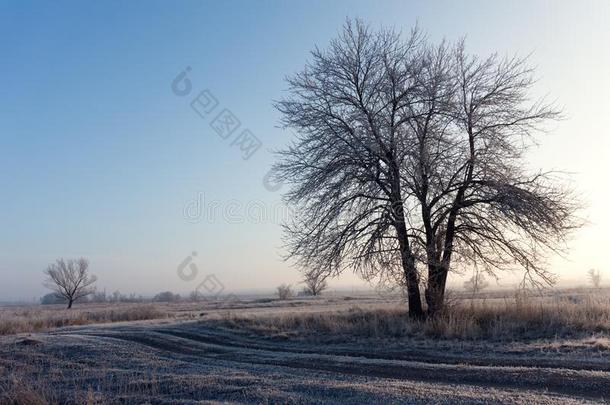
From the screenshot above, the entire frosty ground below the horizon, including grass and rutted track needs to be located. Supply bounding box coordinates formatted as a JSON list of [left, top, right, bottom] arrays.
[[0, 290, 610, 404]]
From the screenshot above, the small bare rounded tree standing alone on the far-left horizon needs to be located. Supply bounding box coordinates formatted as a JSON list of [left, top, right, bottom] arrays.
[[44, 257, 97, 309]]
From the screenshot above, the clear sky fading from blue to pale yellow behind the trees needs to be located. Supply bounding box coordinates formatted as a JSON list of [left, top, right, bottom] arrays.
[[0, 1, 610, 301]]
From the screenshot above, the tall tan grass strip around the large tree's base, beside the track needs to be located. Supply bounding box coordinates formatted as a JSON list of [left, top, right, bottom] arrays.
[[222, 296, 610, 340]]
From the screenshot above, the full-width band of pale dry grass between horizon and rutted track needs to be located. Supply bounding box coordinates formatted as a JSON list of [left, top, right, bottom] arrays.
[[0, 289, 610, 341]]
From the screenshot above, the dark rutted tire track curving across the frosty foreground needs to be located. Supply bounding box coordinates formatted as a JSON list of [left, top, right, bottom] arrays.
[[63, 325, 610, 400]]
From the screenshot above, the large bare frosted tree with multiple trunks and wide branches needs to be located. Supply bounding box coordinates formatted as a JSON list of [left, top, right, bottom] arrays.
[[275, 21, 577, 318]]
